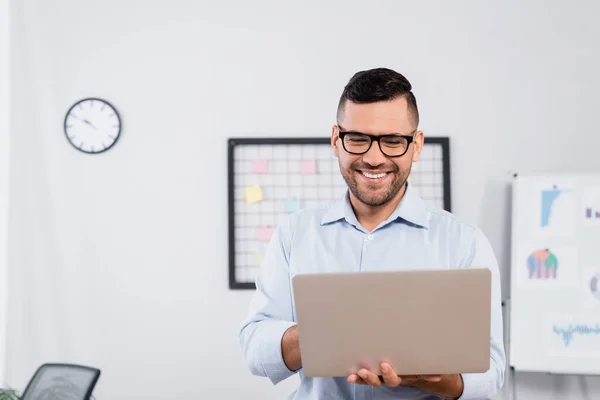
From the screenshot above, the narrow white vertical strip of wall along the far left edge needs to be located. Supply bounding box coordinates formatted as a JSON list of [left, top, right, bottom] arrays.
[[0, 0, 9, 387]]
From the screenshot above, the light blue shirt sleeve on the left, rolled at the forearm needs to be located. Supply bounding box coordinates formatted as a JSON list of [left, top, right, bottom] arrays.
[[238, 214, 296, 384]]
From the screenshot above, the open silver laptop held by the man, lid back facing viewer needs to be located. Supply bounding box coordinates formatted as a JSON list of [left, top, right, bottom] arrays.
[[292, 268, 491, 377]]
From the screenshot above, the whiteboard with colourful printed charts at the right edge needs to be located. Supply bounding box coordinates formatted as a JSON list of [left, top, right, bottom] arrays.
[[509, 173, 600, 375]]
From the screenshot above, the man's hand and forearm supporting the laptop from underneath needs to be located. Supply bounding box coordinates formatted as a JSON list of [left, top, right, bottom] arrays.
[[348, 363, 463, 399]]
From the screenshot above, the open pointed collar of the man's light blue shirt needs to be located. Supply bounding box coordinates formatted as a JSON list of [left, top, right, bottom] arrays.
[[321, 182, 429, 228]]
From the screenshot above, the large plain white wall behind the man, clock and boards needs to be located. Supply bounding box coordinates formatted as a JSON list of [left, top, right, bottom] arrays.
[[8, 0, 600, 400]]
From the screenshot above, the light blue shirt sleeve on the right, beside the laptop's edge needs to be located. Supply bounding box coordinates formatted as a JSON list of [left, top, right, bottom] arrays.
[[459, 229, 506, 400]]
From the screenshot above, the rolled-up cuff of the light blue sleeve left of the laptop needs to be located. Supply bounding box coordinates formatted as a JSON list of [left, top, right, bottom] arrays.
[[260, 321, 296, 385]]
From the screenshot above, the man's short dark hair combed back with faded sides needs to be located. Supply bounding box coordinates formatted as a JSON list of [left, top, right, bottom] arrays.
[[337, 68, 419, 126]]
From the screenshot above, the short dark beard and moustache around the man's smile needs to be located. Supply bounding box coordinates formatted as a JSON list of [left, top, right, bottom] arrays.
[[340, 162, 412, 207]]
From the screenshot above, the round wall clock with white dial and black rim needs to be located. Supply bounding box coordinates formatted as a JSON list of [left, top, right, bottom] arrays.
[[64, 98, 121, 154]]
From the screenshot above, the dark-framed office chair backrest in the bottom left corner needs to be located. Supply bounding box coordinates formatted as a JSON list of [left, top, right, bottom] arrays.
[[21, 364, 100, 400]]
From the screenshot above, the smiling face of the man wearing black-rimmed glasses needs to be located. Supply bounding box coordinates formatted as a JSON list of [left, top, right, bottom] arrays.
[[331, 97, 423, 207]]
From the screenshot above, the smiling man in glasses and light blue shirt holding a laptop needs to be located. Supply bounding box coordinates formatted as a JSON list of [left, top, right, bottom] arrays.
[[240, 68, 505, 400]]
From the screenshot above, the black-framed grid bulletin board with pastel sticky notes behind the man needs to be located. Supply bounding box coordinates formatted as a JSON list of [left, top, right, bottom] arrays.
[[227, 137, 451, 289]]
